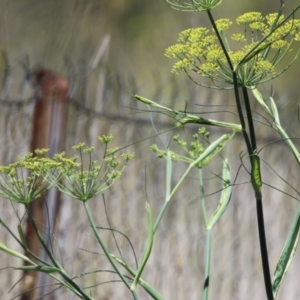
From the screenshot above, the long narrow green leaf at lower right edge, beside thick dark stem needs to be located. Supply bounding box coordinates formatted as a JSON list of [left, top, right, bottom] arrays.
[[272, 205, 300, 297]]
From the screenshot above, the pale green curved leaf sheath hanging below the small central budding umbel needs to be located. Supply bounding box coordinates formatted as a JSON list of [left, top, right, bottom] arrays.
[[207, 159, 232, 230]]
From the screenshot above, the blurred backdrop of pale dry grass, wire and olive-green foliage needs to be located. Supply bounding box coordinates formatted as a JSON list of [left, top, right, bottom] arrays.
[[0, 0, 300, 300]]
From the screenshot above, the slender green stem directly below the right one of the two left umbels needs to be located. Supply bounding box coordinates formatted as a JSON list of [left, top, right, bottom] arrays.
[[83, 201, 139, 300]]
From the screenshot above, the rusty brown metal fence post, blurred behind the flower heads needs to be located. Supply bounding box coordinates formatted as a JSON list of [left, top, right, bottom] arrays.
[[21, 69, 69, 300]]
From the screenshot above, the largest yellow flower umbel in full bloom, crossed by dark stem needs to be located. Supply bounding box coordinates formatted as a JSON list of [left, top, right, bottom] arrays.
[[165, 12, 300, 88]]
